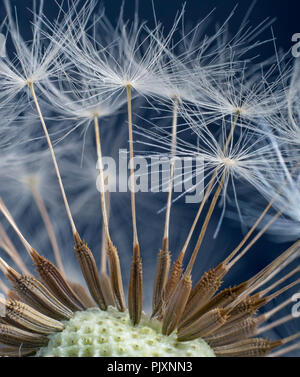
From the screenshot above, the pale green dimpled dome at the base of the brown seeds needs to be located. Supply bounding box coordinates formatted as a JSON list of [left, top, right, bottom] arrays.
[[37, 307, 214, 357]]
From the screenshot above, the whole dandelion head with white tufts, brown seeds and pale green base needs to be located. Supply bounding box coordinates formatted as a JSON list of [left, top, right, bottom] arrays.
[[0, 0, 300, 356]]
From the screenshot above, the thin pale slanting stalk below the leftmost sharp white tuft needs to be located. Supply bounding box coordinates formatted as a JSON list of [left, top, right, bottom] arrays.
[[28, 81, 77, 235]]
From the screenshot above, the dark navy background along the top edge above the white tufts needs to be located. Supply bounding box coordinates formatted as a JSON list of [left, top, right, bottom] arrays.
[[0, 0, 300, 56]]
